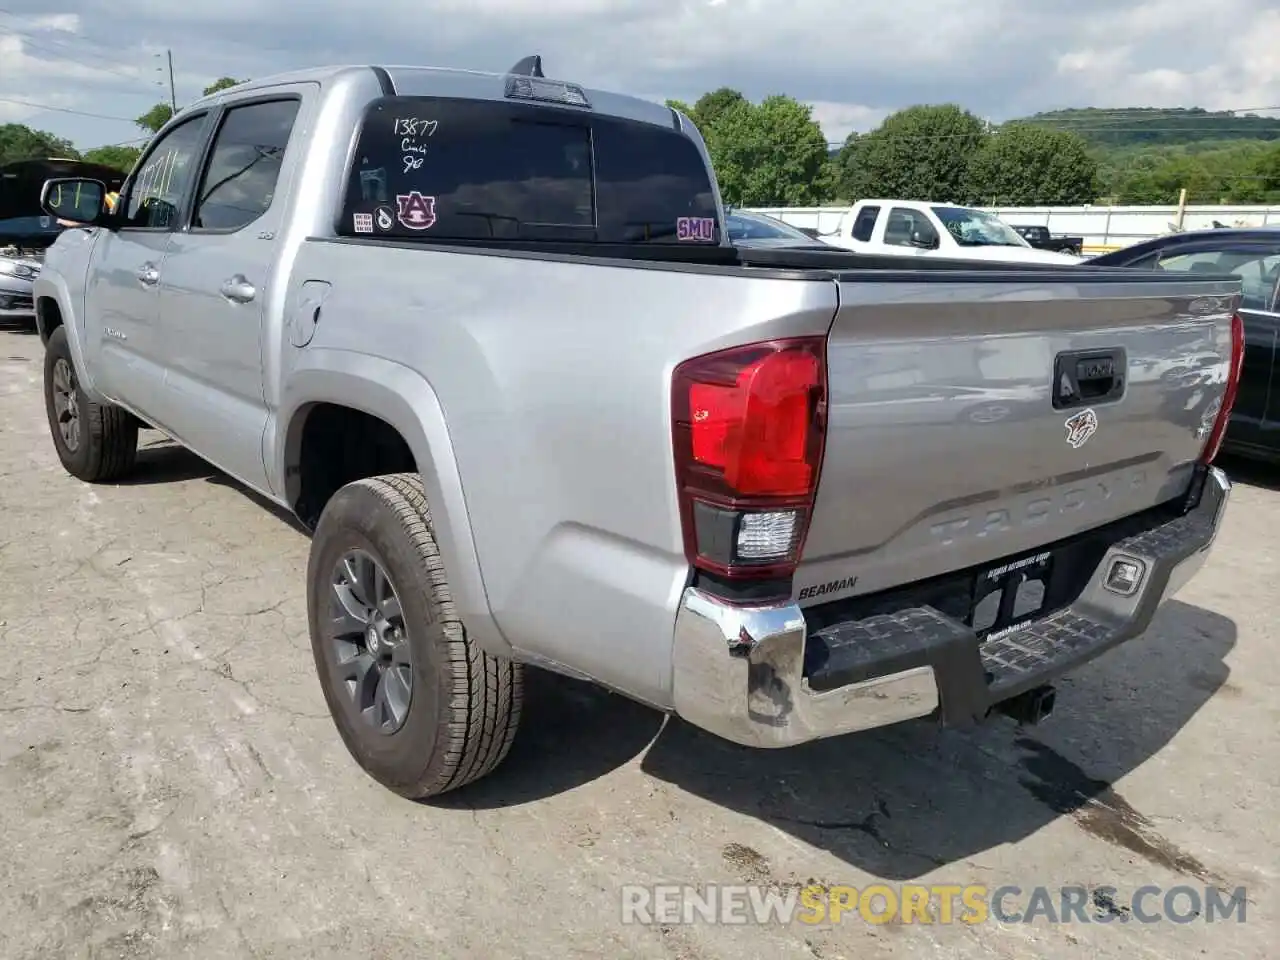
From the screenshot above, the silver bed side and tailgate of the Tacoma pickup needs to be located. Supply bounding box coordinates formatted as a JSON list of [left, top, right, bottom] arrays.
[[282, 238, 1238, 704]]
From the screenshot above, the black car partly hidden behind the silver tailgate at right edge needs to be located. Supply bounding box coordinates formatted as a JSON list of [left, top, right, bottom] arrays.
[[1085, 227, 1280, 461]]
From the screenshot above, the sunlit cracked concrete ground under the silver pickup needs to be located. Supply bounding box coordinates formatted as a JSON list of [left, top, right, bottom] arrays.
[[0, 329, 1280, 960]]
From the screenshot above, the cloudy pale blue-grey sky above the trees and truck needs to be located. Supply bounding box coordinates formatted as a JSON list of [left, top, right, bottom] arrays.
[[0, 0, 1280, 148]]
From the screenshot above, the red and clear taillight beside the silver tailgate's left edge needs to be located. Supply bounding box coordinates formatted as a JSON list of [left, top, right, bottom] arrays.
[[672, 337, 827, 579]]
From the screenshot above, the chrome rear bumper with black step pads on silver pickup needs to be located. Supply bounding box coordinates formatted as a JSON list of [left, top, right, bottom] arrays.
[[673, 468, 1231, 748]]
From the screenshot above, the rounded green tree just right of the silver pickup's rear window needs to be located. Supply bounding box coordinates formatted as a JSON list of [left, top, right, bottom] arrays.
[[695, 96, 832, 206]]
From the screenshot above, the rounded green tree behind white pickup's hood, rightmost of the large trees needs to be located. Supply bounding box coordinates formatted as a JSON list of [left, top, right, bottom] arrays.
[[964, 123, 1098, 206]]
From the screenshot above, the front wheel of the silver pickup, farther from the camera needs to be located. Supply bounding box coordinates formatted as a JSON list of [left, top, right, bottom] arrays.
[[45, 326, 138, 484]]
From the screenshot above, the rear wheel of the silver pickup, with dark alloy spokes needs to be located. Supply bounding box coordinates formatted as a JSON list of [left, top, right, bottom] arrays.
[[307, 474, 522, 800]]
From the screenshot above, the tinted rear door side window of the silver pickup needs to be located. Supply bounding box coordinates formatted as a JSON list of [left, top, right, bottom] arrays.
[[191, 100, 301, 230]]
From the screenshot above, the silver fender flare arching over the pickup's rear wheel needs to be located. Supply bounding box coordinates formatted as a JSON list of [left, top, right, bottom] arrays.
[[273, 347, 512, 657]]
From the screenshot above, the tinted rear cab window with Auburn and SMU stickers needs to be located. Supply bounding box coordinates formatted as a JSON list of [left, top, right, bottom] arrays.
[[337, 97, 722, 247]]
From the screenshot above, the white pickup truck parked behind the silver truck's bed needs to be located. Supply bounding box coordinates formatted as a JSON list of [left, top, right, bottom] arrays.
[[818, 200, 1080, 264]]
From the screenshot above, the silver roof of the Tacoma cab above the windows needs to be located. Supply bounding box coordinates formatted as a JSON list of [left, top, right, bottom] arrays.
[[184, 64, 675, 127]]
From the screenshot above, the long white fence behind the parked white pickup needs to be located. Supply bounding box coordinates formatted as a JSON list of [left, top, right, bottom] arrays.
[[750, 206, 1280, 253]]
